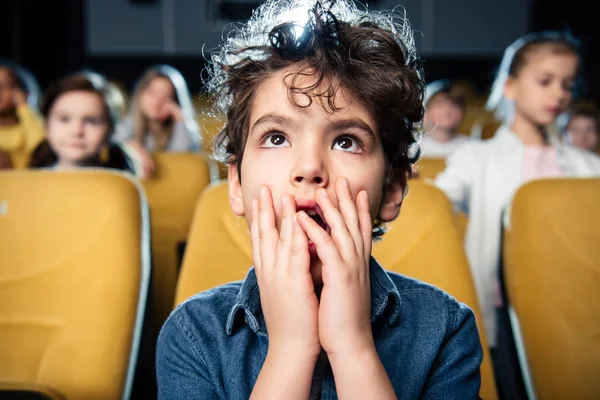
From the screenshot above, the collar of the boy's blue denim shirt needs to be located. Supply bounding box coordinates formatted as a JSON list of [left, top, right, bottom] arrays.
[[225, 257, 400, 335]]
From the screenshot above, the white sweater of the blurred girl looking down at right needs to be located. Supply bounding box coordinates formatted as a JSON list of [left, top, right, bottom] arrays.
[[436, 127, 600, 347]]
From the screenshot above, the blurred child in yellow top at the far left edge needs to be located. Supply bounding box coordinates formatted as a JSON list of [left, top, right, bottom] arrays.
[[0, 62, 45, 168]]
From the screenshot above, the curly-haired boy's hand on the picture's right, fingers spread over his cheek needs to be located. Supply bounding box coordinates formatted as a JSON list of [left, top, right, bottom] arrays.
[[298, 179, 375, 359]]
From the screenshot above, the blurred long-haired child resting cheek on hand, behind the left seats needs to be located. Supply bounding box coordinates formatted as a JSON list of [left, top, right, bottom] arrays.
[[114, 65, 200, 176]]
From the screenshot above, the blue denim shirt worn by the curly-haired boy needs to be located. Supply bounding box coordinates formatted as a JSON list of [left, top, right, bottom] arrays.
[[156, 258, 482, 400]]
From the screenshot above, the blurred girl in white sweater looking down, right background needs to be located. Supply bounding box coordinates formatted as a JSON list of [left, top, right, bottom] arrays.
[[436, 32, 600, 354]]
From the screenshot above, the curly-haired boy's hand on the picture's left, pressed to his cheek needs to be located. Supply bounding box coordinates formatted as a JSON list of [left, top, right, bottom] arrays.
[[250, 187, 321, 360]]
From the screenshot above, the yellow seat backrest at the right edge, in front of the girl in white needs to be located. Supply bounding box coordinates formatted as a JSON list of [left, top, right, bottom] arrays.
[[503, 179, 600, 399]]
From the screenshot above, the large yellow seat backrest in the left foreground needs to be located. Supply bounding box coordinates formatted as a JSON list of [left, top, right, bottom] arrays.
[[0, 169, 150, 399]]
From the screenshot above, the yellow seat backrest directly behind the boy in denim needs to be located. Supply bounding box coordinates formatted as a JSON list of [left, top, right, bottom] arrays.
[[176, 181, 496, 399]]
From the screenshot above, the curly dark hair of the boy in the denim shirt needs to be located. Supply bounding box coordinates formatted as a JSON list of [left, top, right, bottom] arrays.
[[206, 0, 424, 234]]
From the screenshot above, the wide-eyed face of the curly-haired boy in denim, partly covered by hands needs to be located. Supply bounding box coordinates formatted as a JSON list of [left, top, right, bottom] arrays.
[[229, 69, 404, 281]]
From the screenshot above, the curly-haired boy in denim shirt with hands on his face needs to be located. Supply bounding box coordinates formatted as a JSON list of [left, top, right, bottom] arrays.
[[157, 0, 482, 399]]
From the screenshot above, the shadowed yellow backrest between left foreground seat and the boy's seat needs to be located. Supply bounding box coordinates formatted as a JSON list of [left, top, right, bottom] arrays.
[[142, 153, 211, 327]]
